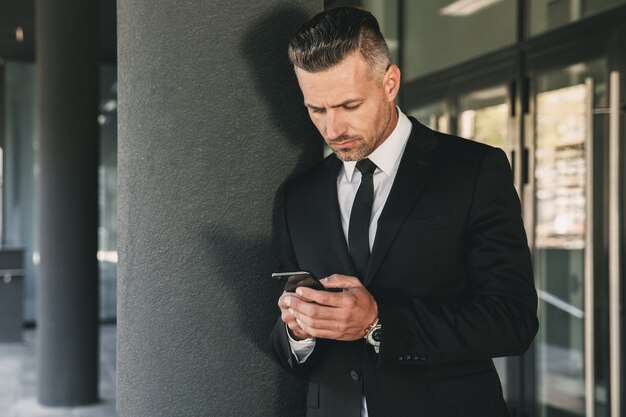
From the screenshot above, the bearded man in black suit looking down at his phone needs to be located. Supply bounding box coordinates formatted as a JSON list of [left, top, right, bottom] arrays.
[[272, 8, 538, 417]]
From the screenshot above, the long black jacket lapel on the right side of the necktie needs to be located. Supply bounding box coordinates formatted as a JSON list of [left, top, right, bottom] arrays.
[[365, 118, 437, 286]]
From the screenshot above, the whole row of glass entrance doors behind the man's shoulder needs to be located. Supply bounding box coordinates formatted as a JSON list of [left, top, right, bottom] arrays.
[[410, 54, 626, 417]]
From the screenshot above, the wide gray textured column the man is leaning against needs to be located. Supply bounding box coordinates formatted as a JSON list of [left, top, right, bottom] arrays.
[[117, 0, 322, 417]]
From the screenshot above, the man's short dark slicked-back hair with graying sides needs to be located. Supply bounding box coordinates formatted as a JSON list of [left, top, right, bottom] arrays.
[[288, 7, 391, 77]]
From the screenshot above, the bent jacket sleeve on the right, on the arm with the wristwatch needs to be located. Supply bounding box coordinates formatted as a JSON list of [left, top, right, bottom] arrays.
[[378, 149, 538, 365]]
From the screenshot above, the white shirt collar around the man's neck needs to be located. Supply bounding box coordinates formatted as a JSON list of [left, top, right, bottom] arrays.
[[343, 107, 413, 182]]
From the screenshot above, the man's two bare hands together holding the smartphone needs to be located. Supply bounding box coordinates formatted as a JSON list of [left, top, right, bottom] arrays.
[[279, 274, 378, 341]]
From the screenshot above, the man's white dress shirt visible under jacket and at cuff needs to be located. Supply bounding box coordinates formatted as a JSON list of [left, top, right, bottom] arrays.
[[287, 107, 412, 417]]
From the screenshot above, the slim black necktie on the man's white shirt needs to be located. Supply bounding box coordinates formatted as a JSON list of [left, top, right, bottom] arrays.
[[348, 159, 376, 281]]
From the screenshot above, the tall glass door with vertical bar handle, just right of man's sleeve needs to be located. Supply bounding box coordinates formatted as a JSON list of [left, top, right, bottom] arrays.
[[527, 60, 609, 417]]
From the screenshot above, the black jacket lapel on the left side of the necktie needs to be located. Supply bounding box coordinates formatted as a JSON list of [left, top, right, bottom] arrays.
[[316, 156, 356, 275]]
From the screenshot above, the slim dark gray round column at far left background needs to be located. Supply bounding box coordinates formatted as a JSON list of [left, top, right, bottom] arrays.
[[35, 0, 98, 406]]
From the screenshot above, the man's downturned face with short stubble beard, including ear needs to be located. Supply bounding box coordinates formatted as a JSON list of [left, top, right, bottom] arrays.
[[296, 52, 400, 161]]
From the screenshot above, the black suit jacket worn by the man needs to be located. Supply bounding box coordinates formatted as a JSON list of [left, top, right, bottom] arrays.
[[272, 119, 538, 417]]
